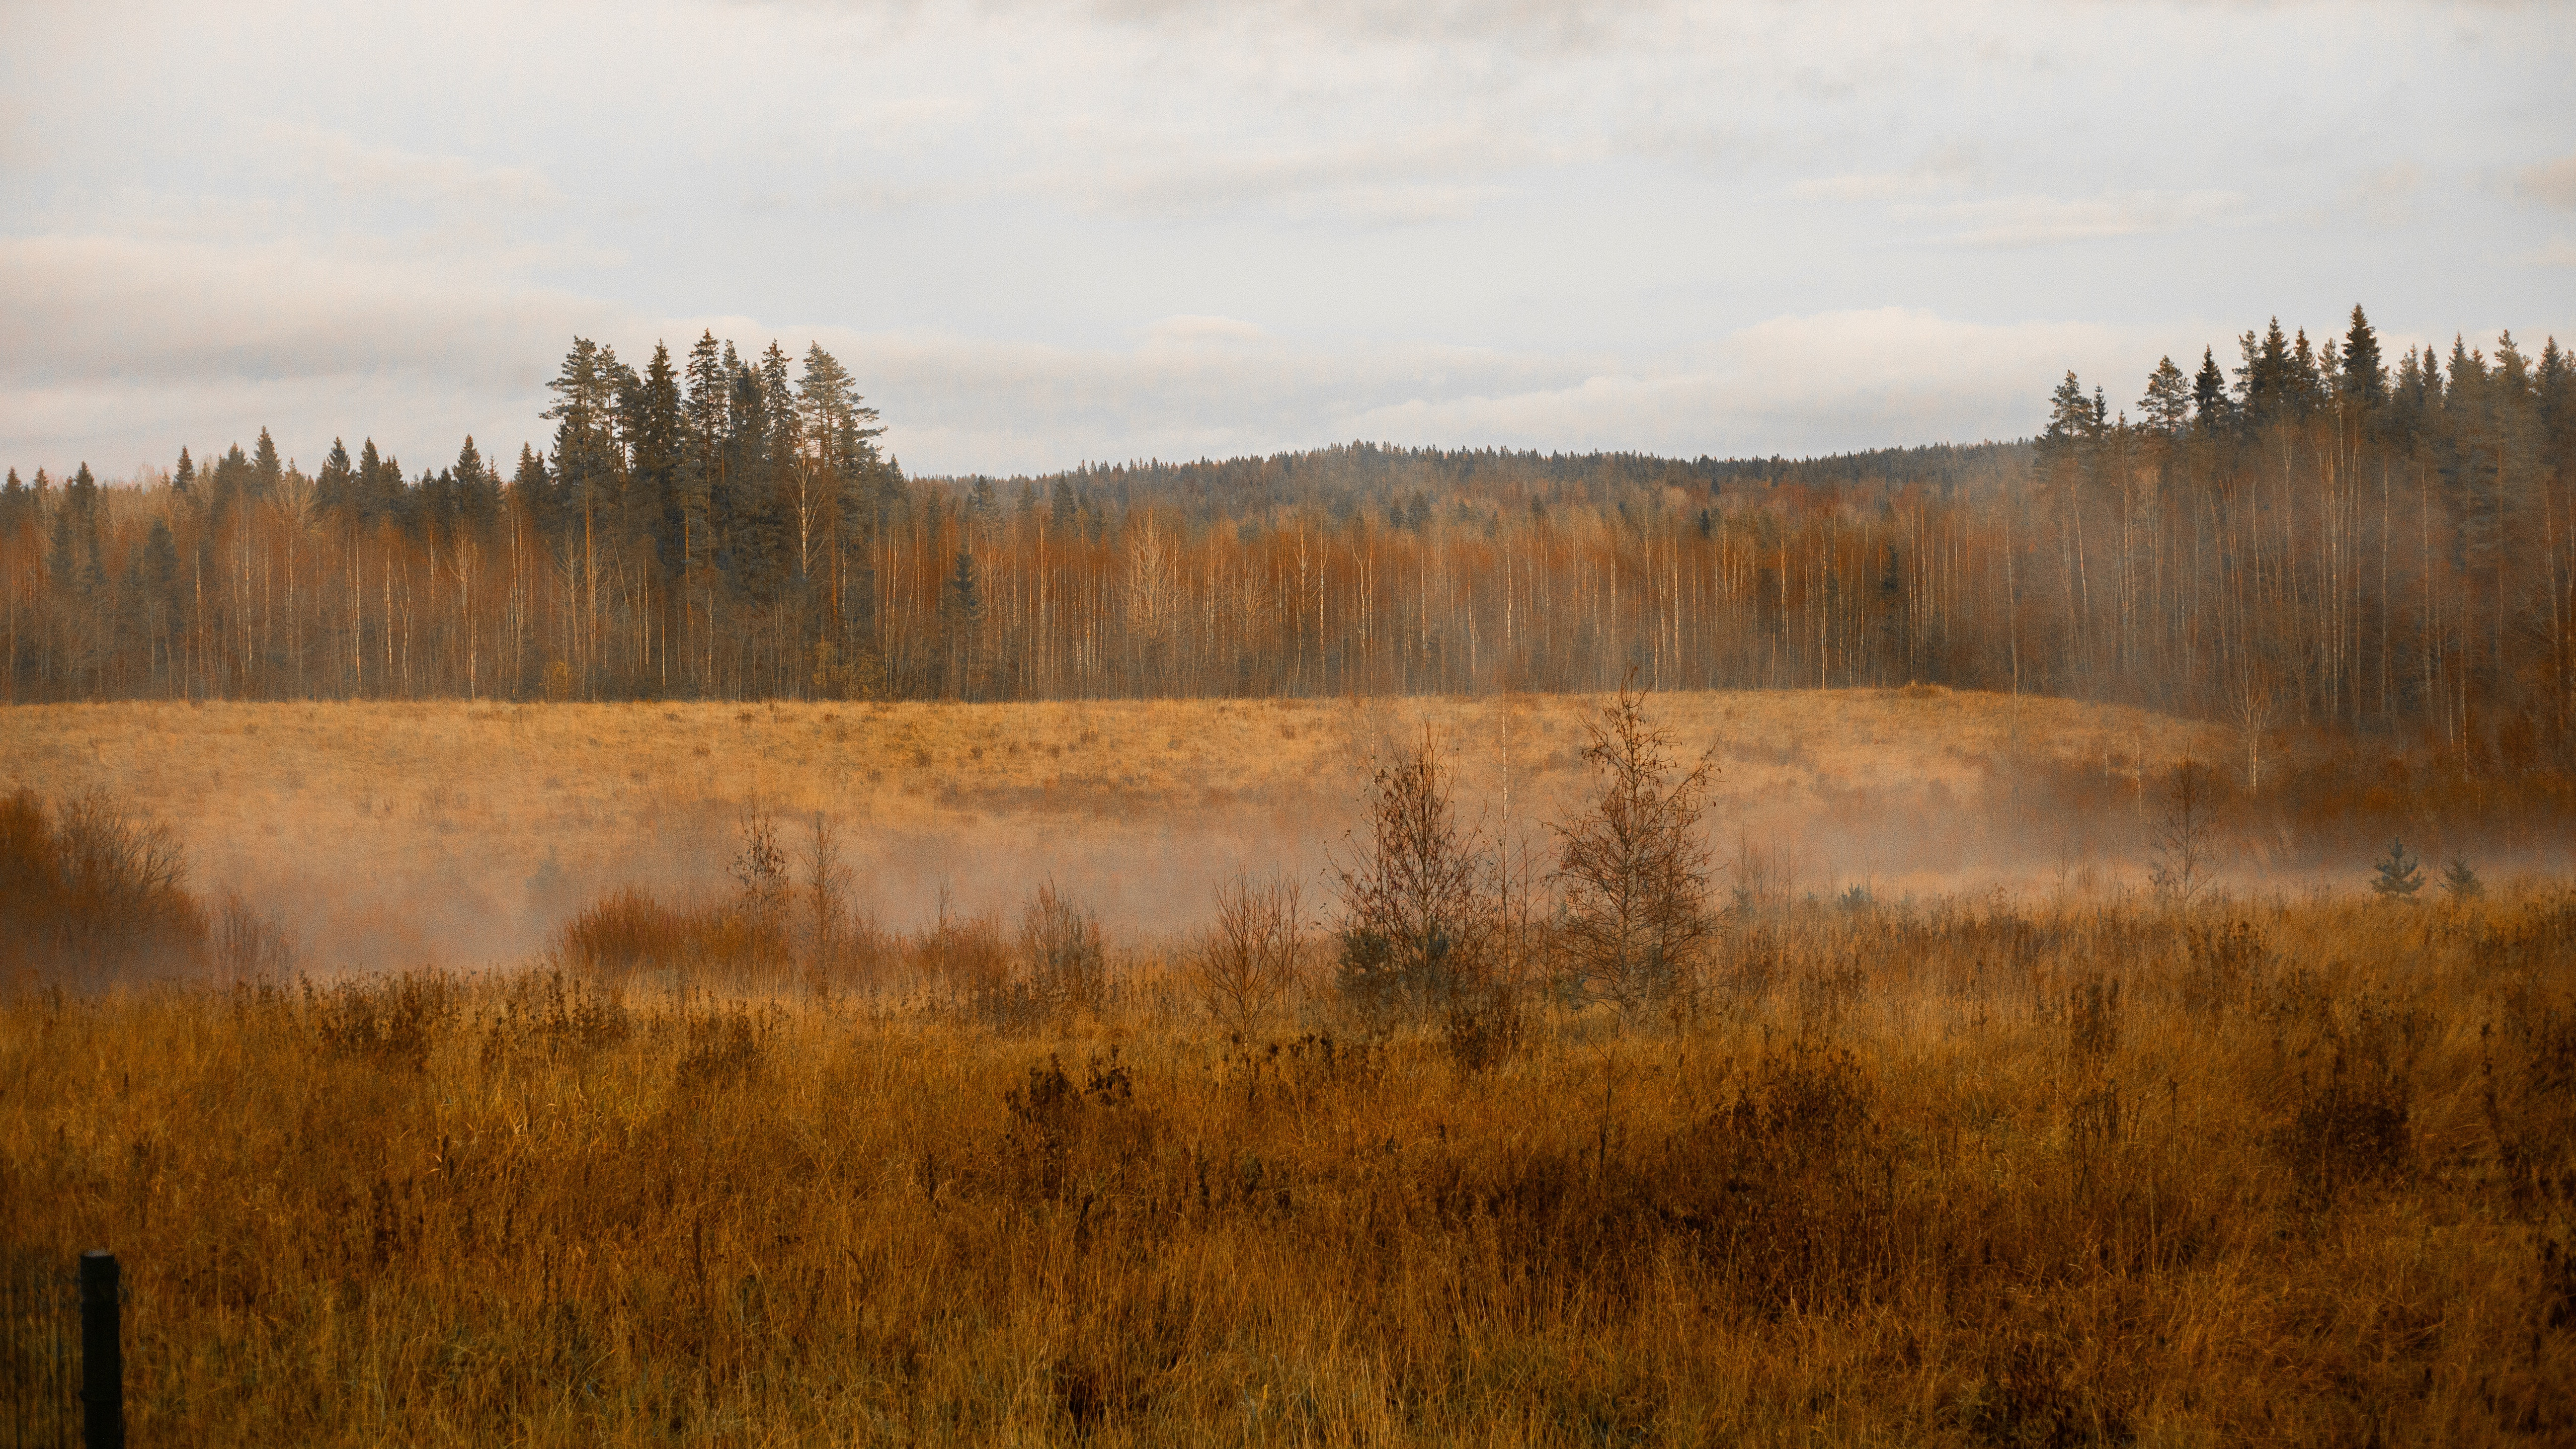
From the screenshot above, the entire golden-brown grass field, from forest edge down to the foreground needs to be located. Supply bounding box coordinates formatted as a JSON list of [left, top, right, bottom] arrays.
[[0, 691, 2576, 1446]]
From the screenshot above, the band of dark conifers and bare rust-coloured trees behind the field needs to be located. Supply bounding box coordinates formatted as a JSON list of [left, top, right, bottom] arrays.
[[0, 307, 2576, 753]]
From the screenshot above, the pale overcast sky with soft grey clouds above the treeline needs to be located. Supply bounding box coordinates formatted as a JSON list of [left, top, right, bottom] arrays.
[[0, 0, 2576, 477]]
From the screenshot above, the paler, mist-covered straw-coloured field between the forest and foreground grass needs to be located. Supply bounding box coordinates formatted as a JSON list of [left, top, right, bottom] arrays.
[[0, 688, 2226, 970]]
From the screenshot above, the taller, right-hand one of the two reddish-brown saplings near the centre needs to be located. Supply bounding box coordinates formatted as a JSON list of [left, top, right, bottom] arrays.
[[1553, 681, 1716, 1011]]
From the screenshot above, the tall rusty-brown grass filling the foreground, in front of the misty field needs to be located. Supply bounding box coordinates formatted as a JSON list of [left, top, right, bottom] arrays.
[[0, 892, 2576, 1444]]
